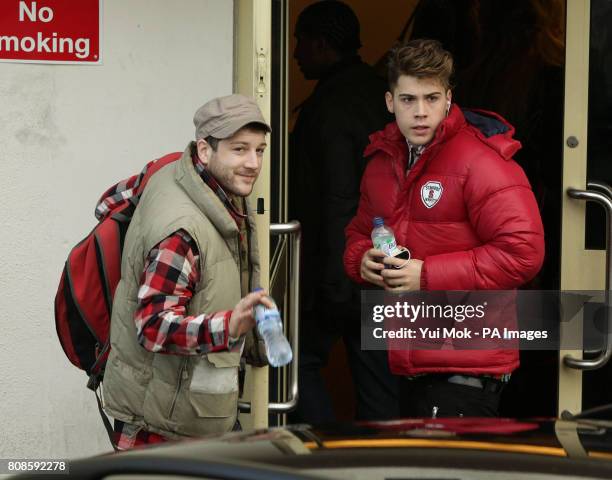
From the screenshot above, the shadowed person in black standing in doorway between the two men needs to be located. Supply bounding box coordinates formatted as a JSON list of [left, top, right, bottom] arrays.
[[289, 0, 399, 423]]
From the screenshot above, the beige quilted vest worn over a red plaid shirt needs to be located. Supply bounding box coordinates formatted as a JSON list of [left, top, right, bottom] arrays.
[[103, 145, 259, 438]]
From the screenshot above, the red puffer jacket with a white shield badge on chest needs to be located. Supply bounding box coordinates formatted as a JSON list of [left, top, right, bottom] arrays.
[[344, 105, 544, 375]]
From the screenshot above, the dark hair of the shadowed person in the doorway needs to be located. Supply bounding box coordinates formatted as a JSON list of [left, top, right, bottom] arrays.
[[295, 0, 361, 52]]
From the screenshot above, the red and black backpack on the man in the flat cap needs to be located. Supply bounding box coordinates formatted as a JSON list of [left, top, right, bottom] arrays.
[[55, 153, 182, 447]]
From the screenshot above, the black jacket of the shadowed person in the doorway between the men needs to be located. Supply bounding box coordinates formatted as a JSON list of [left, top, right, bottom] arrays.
[[289, 57, 391, 310]]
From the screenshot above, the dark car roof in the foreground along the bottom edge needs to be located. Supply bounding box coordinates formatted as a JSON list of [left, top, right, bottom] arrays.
[[10, 418, 612, 480]]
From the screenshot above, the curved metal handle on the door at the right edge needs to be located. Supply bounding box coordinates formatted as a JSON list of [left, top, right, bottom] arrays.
[[563, 186, 612, 370]]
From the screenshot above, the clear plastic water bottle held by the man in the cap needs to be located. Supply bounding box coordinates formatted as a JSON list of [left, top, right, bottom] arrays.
[[253, 297, 293, 367]]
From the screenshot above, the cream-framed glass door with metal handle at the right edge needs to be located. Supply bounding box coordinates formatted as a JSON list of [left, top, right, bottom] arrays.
[[558, 0, 612, 413]]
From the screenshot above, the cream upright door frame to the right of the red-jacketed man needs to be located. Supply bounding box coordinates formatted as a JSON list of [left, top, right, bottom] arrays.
[[558, 0, 606, 415]]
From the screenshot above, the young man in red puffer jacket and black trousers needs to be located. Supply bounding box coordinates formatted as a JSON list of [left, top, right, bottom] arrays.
[[344, 40, 544, 417]]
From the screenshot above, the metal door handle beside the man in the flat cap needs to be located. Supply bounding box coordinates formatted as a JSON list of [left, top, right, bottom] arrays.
[[238, 220, 302, 413]]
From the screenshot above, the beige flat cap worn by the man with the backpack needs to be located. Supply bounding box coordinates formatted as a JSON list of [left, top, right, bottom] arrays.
[[193, 93, 272, 140]]
